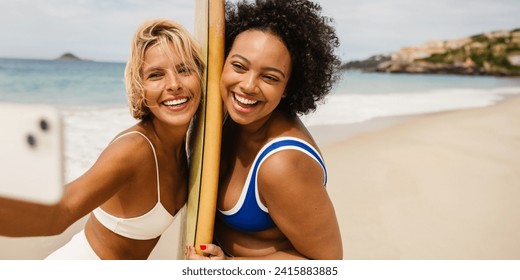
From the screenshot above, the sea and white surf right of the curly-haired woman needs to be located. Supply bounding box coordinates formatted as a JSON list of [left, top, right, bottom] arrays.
[[303, 71, 520, 126]]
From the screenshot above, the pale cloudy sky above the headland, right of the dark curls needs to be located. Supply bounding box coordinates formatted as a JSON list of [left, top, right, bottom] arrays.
[[319, 0, 520, 60]]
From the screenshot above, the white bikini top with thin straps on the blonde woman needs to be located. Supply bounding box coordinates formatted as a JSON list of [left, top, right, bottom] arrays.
[[92, 131, 175, 240]]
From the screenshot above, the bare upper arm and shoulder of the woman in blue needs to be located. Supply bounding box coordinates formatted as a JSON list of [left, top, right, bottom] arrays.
[[258, 150, 343, 259]]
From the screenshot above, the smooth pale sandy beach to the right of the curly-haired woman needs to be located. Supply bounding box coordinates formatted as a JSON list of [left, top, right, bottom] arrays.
[[311, 97, 520, 260]]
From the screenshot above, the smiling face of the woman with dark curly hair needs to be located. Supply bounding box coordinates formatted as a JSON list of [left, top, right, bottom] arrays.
[[220, 30, 291, 125]]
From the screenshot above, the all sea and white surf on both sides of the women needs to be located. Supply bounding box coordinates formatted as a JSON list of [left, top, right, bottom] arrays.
[[0, 59, 520, 180]]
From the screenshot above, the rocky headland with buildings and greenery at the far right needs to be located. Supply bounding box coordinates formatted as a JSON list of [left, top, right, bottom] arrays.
[[341, 28, 520, 76]]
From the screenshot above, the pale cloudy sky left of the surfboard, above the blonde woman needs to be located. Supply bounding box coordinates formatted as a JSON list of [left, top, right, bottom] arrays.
[[0, 0, 194, 61]]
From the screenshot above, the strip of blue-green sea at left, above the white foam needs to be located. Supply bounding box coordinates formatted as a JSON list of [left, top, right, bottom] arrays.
[[0, 59, 126, 106]]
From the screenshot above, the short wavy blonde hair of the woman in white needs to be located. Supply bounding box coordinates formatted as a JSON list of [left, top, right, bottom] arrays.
[[125, 19, 205, 119]]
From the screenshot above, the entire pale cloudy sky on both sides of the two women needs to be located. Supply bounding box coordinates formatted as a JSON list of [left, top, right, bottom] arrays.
[[0, 0, 520, 62]]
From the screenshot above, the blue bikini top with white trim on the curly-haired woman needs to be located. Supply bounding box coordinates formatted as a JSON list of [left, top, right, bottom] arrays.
[[218, 137, 327, 232]]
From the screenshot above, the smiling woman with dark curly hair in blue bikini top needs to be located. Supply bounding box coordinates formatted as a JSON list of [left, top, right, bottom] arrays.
[[186, 0, 343, 260]]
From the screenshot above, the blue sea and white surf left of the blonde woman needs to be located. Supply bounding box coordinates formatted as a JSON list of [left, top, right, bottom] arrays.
[[0, 59, 136, 182]]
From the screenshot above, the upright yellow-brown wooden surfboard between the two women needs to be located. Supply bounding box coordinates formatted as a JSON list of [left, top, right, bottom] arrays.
[[185, 0, 225, 254]]
